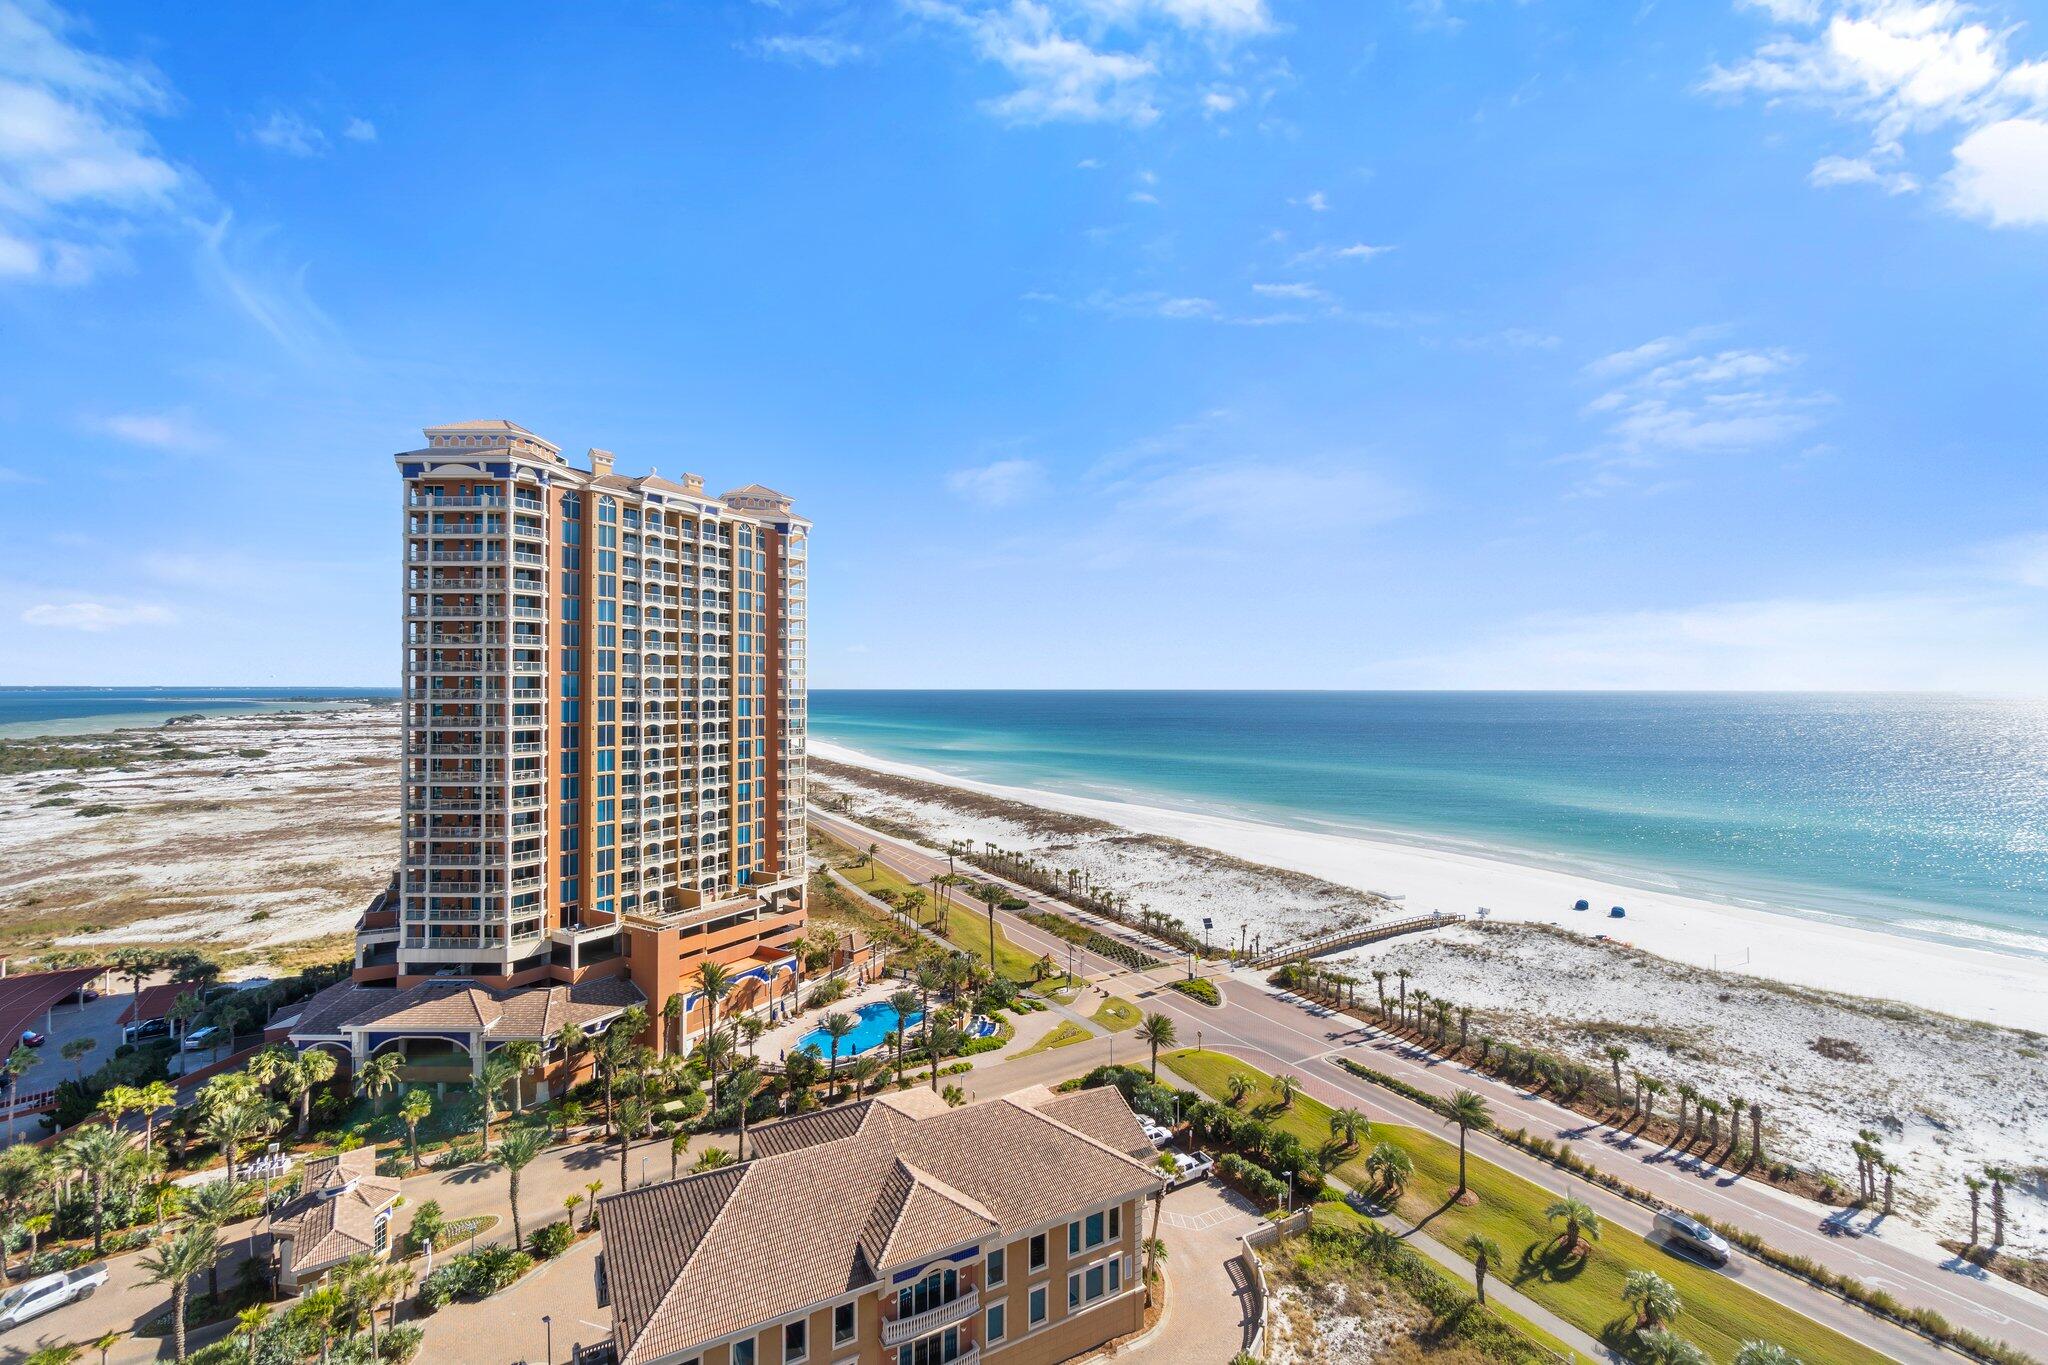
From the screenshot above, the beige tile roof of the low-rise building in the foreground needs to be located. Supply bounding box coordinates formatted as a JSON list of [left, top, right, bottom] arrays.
[[600, 1089, 1159, 1365]]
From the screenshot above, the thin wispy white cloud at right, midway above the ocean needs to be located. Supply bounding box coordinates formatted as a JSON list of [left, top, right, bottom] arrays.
[[1571, 329, 1831, 493]]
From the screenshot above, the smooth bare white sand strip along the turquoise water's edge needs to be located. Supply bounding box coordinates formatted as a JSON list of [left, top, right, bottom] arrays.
[[811, 737, 2048, 1031]]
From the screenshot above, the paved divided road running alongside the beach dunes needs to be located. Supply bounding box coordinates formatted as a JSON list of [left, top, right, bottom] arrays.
[[813, 812, 2048, 1361]]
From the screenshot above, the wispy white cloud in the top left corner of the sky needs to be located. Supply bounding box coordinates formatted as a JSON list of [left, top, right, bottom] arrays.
[[0, 0, 186, 284]]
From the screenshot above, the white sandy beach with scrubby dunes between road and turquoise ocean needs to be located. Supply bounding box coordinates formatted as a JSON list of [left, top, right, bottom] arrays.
[[811, 739, 2048, 1252]]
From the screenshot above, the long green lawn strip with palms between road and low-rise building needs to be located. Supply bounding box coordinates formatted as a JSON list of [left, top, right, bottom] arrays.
[[1161, 1050, 1886, 1365]]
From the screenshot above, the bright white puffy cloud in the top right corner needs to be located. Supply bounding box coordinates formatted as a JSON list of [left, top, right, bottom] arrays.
[[1700, 0, 2048, 227]]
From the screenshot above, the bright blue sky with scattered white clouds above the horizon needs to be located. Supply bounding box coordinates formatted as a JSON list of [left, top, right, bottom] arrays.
[[0, 0, 2048, 692]]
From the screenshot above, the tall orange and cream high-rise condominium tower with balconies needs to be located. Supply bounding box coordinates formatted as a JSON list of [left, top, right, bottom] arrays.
[[378, 422, 809, 1009]]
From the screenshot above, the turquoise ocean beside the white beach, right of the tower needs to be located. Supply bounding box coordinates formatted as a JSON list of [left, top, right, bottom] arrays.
[[811, 690, 2048, 956]]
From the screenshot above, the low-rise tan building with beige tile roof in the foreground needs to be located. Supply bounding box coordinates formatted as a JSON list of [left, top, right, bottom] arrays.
[[600, 1087, 1161, 1365]]
